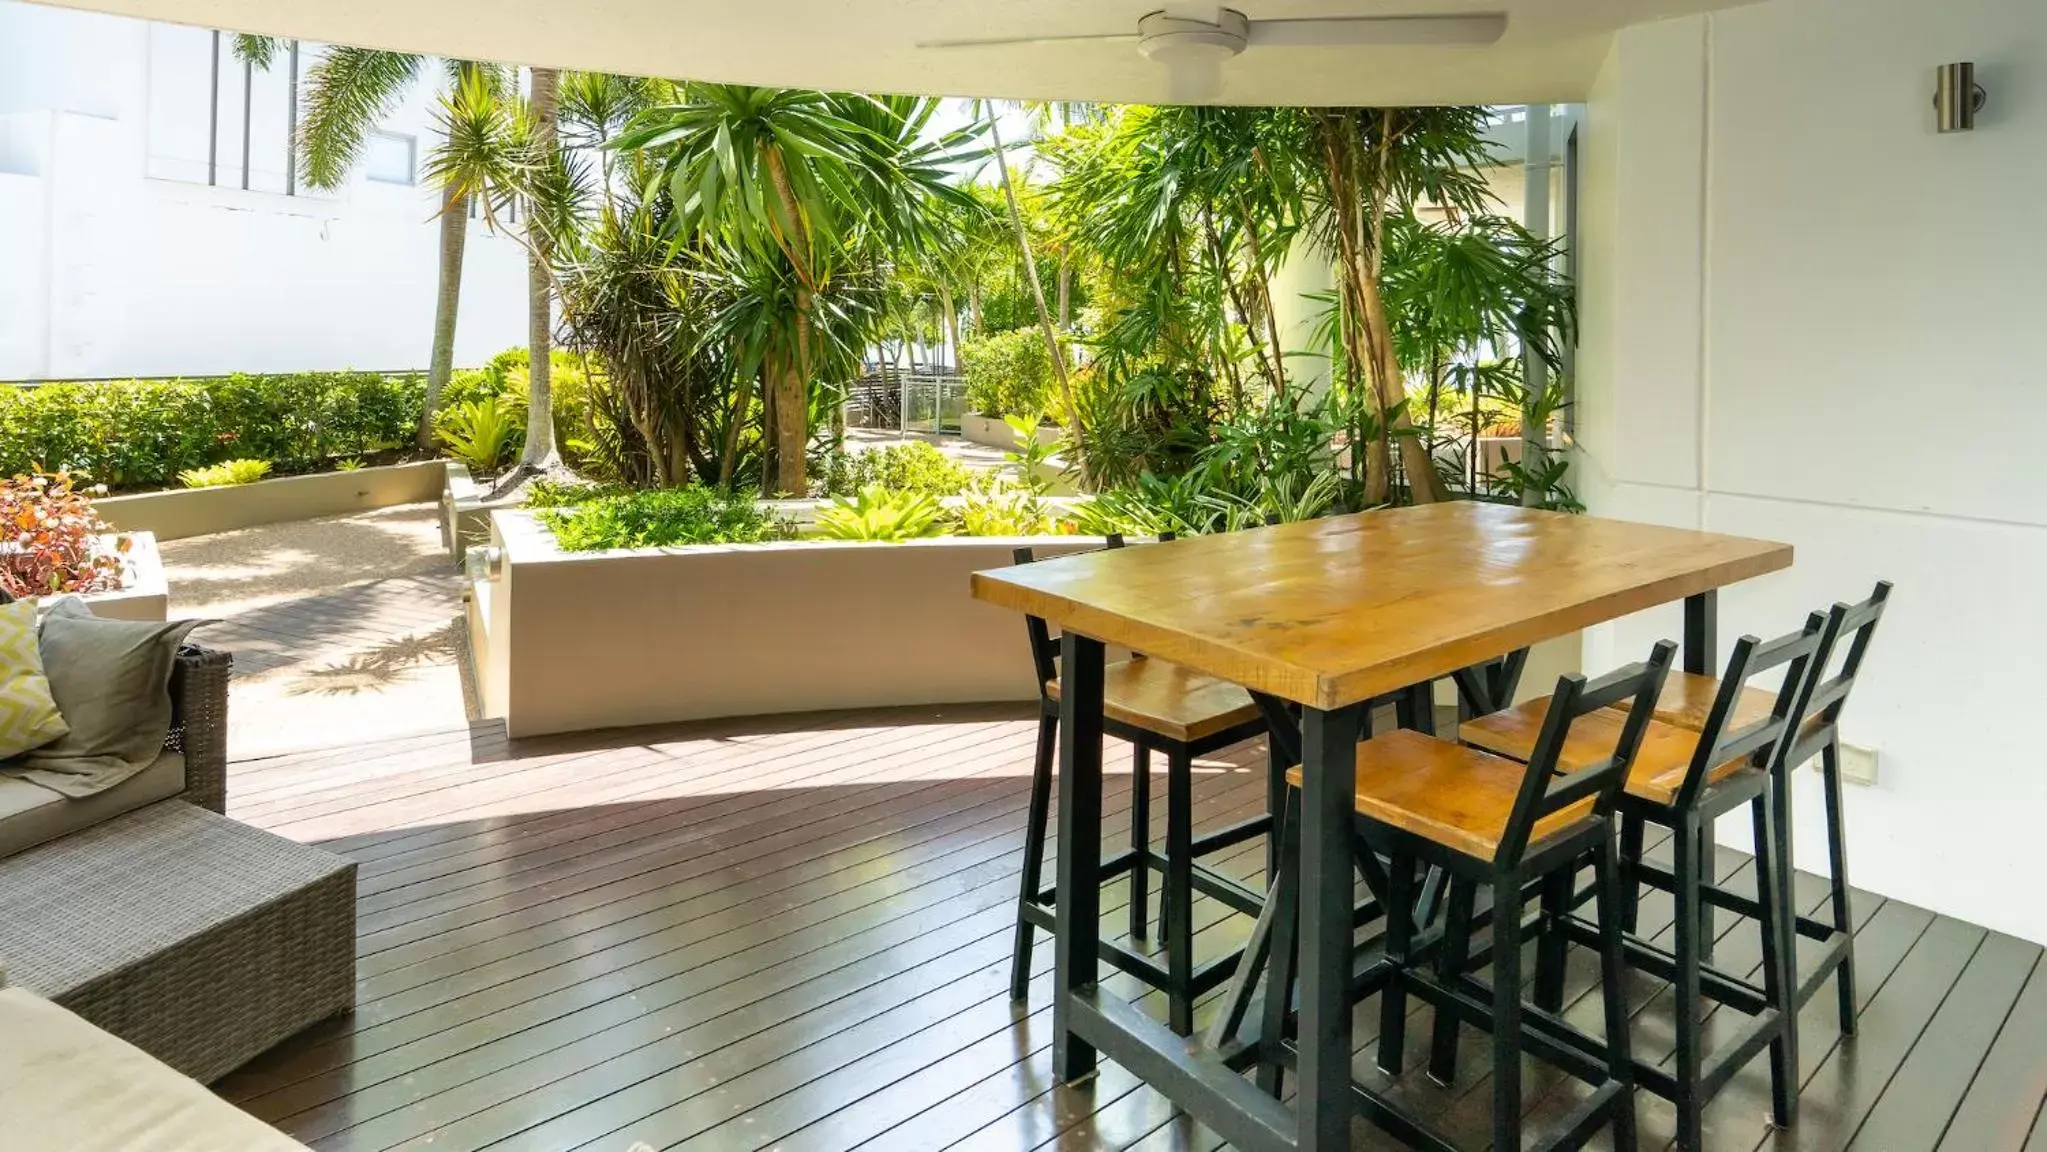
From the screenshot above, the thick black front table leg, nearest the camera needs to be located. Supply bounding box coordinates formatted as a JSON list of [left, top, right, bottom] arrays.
[[1293, 704, 1361, 1152]]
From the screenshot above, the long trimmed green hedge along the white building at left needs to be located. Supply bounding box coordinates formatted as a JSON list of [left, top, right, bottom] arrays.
[[0, 372, 426, 489]]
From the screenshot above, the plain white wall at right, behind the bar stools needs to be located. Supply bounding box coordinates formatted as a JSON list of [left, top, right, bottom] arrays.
[[1580, 0, 2047, 941]]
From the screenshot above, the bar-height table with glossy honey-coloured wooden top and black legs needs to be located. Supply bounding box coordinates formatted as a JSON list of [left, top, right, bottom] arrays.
[[972, 501, 1791, 1152]]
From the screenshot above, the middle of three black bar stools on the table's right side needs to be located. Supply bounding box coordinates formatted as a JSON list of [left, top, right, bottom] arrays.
[[1435, 614, 1824, 1152]]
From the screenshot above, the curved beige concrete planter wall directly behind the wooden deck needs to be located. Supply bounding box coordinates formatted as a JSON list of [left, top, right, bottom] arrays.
[[469, 512, 1101, 737]]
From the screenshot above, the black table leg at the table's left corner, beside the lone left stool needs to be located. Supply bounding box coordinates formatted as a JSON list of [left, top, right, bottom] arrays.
[[1052, 632, 1103, 1082]]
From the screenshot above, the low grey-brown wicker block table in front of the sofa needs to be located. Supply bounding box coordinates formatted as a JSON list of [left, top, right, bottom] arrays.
[[0, 800, 356, 1082]]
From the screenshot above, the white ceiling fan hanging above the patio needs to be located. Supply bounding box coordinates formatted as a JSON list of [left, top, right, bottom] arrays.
[[917, 4, 1507, 102]]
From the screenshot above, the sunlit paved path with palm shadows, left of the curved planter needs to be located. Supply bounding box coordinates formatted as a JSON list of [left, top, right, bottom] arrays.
[[164, 503, 469, 759]]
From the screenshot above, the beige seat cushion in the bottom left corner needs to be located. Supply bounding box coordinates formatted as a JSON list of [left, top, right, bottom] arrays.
[[0, 988, 305, 1152]]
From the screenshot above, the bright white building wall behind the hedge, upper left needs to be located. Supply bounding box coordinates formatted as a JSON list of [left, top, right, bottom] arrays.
[[0, 0, 526, 381]]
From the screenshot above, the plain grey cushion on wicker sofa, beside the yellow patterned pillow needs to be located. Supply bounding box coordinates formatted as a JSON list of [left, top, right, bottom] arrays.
[[6, 597, 205, 798]]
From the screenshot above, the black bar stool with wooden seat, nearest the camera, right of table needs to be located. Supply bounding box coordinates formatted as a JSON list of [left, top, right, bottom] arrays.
[[1224, 643, 1676, 1152]]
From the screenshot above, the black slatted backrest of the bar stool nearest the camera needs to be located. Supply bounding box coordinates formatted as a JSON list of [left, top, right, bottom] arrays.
[[1492, 640, 1676, 868]]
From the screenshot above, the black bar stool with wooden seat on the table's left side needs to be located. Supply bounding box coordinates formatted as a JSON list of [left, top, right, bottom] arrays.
[[1009, 536, 1283, 1035]]
